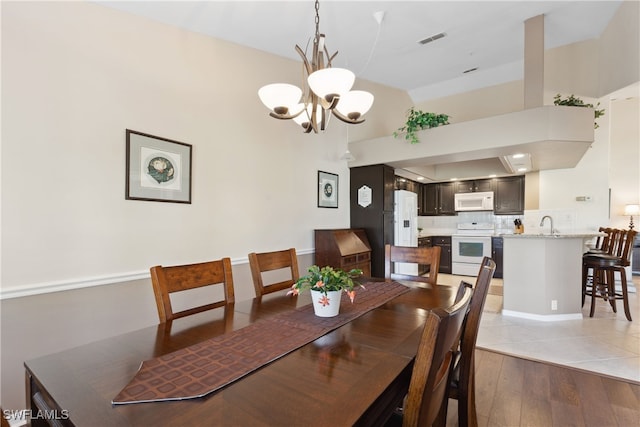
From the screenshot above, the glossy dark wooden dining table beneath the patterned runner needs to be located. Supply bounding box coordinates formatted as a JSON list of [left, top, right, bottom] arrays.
[[24, 282, 455, 426]]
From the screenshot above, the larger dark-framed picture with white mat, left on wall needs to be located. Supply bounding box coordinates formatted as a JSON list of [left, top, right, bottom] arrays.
[[125, 129, 191, 203]]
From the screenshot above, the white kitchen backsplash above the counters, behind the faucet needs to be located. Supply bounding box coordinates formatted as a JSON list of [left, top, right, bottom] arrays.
[[418, 209, 597, 236]]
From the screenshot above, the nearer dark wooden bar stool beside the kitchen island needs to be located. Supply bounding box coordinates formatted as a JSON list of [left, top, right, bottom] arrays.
[[582, 229, 637, 321]]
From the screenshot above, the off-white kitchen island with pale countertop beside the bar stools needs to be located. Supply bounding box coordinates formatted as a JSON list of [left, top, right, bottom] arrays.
[[502, 233, 598, 321]]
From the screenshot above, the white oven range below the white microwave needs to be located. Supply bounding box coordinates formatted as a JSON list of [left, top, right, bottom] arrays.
[[451, 222, 495, 276]]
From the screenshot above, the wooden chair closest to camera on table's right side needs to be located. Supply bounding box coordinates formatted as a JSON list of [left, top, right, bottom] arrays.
[[402, 287, 472, 427]]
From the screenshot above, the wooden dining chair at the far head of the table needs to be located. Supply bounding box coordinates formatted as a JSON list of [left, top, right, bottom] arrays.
[[384, 244, 442, 285]]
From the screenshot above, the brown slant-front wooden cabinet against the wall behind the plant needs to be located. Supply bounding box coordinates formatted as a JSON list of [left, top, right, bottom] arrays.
[[315, 228, 371, 277]]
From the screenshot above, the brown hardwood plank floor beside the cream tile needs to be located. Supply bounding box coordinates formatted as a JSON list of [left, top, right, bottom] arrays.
[[447, 349, 640, 427]]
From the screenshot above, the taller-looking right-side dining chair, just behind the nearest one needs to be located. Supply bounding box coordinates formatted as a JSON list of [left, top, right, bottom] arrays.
[[437, 257, 496, 427]]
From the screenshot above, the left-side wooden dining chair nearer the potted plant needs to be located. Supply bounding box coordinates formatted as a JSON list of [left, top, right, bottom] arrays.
[[249, 248, 300, 296]]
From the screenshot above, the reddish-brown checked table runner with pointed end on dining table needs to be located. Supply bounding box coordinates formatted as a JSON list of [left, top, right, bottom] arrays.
[[111, 282, 409, 404]]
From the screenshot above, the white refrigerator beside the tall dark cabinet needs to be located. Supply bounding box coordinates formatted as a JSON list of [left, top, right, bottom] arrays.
[[393, 190, 418, 276]]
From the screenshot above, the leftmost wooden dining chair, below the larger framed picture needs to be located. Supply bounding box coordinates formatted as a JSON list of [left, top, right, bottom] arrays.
[[150, 258, 235, 322]]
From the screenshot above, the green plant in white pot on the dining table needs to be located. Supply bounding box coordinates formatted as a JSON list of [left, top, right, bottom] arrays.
[[287, 265, 364, 317]]
